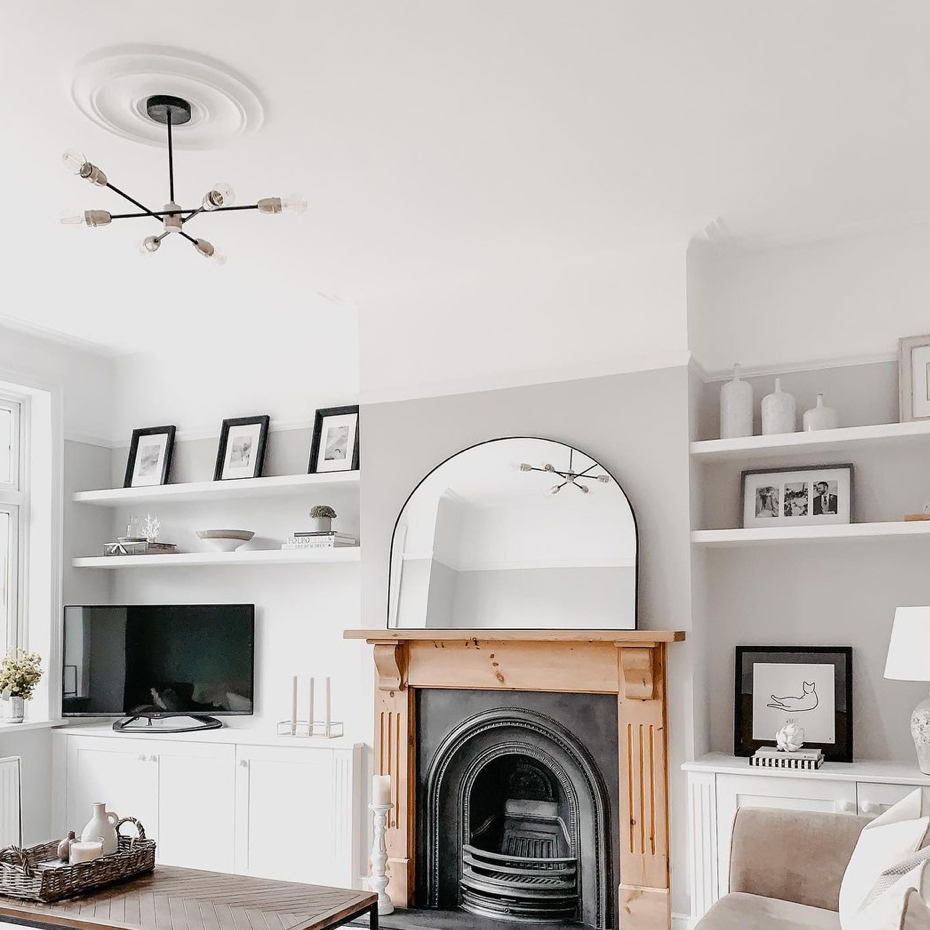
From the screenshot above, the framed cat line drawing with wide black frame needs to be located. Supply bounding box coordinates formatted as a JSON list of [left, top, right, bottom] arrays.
[[733, 646, 853, 762]]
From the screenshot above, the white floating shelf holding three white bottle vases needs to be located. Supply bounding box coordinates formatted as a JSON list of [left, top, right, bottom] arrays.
[[691, 420, 930, 462]]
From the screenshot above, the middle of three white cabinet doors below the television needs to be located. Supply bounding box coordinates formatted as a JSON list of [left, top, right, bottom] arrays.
[[156, 740, 236, 872]]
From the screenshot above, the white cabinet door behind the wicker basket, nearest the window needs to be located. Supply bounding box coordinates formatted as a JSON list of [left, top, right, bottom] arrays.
[[65, 736, 158, 840]]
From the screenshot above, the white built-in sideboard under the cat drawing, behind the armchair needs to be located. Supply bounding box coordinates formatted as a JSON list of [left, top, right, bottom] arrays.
[[682, 752, 930, 923]]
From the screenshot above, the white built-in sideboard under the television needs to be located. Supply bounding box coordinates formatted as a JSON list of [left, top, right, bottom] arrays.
[[53, 726, 362, 888]]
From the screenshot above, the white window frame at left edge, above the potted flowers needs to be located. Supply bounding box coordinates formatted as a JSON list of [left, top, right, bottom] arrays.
[[0, 393, 29, 649]]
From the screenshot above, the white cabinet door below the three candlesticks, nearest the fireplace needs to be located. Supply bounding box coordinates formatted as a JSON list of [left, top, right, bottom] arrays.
[[236, 746, 351, 885]]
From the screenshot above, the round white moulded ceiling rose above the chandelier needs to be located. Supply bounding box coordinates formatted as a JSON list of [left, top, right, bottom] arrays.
[[71, 45, 265, 150]]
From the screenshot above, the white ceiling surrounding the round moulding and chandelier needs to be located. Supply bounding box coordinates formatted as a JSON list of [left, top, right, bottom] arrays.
[[0, 0, 930, 380]]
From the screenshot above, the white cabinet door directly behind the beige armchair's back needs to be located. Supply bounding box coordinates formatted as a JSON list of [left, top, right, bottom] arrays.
[[716, 775, 857, 896]]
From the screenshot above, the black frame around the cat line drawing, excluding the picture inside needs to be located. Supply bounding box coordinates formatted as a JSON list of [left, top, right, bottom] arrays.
[[733, 646, 853, 762]]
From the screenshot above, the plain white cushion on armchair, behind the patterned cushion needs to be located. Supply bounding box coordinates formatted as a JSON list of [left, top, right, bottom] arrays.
[[840, 788, 930, 927]]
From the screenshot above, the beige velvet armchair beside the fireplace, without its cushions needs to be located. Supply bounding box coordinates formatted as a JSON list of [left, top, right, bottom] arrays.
[[695, 807, 869, 930]]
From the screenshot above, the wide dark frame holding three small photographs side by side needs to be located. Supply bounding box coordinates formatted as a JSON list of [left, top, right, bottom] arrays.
[[740, 465, 853, 529]]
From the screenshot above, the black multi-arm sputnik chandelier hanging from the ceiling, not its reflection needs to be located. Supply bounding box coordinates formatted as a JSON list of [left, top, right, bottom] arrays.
[[61, 94, 307, 265]]
